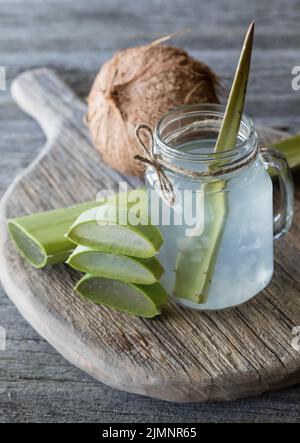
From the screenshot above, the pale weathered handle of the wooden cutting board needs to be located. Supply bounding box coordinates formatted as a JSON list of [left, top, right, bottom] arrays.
[[11, 68, 86, 139]]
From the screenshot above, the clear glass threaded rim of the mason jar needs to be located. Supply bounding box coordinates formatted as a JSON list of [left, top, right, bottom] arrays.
[[154, 103, 257, 163]]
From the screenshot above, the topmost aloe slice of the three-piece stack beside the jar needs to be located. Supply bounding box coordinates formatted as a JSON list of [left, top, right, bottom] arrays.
[[67, 205, 163, 258]]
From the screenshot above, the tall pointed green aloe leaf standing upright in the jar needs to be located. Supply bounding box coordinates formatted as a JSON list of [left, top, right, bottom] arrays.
[[174, 23, 254, 303]]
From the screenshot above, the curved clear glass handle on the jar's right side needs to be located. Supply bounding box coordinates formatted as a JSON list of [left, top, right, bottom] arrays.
[[259, 147, 294, 240]]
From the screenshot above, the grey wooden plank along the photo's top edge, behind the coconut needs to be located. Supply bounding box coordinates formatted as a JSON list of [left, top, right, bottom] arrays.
[[0, 0, 299, 52]]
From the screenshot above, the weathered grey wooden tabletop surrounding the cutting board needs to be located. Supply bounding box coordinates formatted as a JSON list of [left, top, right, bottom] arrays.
[[0, 0, 300, 423]]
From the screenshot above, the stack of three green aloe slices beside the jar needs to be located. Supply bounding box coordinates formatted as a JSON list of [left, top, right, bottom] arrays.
[[67, 199, 168, 318]]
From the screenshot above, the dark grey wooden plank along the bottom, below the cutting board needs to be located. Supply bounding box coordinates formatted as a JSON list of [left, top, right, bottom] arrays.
[[0, 371, 300, 423]]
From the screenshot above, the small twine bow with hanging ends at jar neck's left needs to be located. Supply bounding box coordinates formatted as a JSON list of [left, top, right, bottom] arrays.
[[134, 124, 175, 206]]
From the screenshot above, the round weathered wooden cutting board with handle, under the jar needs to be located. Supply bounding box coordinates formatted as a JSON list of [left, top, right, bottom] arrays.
[[0, 69, 300, 402]]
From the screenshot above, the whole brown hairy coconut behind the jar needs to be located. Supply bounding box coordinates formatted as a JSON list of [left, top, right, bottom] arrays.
[[86, 43, 219, 175]]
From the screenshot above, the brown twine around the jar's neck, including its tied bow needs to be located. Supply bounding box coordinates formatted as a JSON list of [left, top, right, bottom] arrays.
[[134, 124, 258, 206]]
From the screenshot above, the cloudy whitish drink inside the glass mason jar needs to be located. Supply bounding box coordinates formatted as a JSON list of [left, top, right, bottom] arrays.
[[147, 140, 273, 310]]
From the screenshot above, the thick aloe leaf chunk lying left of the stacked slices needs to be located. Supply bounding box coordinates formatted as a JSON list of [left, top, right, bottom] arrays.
[[8, 201, 97, 268]]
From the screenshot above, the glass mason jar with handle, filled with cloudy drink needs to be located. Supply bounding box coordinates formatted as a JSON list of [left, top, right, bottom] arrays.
[[146, 104, 293, 310]]
